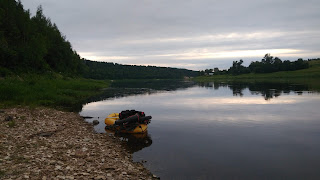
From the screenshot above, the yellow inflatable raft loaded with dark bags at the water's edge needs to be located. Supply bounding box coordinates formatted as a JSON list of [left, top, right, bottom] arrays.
[[105, 110, 152, 133]]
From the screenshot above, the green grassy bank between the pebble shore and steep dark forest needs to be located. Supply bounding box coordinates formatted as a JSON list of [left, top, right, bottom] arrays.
[[0, 75, 110, 111]]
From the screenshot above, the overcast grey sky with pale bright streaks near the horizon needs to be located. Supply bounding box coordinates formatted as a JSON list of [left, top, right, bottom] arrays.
[[21, 0, 320, 70]]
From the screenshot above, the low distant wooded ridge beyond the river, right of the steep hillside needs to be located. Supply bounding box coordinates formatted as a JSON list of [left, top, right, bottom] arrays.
[[83, 60, 198, 79]]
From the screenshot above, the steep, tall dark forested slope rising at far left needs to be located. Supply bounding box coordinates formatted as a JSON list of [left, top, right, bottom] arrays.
[[0, 0, 82, 74]]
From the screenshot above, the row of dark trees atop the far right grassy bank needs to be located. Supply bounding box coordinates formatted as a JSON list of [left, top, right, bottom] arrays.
[[200, 54, 309, 75]]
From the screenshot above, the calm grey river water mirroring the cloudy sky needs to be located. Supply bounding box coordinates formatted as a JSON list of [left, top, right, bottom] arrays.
[[80, 83, 320, 179]]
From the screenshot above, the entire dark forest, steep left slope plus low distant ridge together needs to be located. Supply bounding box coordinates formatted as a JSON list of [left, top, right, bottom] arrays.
[[0, 0, 198, 79]]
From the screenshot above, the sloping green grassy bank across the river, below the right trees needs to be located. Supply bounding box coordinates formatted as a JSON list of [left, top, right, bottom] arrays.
[[194, 61, 320, 82]]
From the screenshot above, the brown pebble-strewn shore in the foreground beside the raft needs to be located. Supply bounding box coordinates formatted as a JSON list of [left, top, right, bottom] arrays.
[[0, 108, 155, 180]]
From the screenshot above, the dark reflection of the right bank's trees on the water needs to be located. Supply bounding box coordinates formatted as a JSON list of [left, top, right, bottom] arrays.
[[199, 82, 309, 100]]
